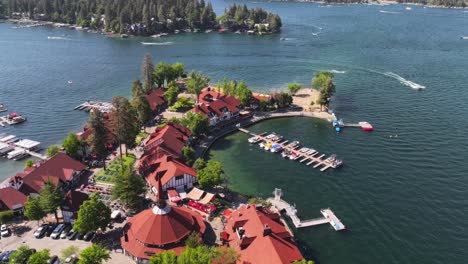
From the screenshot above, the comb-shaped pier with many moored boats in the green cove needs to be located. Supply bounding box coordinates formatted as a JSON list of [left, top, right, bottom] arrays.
[[239, 128, 342, 172]]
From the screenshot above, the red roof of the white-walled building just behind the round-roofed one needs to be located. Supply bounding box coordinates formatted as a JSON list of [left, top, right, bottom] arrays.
[[146, 155, 197, 188]]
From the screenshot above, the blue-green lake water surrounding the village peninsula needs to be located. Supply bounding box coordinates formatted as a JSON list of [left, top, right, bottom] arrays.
[[0, 1, 468, 264]]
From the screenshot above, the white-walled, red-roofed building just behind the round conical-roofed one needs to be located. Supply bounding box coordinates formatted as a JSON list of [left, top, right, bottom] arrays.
[[144, 155, 197, 193]]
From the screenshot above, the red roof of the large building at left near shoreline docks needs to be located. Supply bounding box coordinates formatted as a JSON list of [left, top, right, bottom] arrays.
[[20, 152, 86, 194]]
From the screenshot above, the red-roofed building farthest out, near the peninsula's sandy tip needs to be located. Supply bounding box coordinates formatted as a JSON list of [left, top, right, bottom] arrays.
[[192, 87, 241, 126]]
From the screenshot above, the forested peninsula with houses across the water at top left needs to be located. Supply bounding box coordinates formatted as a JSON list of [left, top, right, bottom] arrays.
[[0, 0, 281, 36]]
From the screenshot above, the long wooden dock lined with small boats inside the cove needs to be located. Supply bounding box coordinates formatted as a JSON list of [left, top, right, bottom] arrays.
[[239, 128, 344, 172]]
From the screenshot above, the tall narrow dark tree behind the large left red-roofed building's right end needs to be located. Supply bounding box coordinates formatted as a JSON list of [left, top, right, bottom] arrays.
[[88, 109, 107, 169]]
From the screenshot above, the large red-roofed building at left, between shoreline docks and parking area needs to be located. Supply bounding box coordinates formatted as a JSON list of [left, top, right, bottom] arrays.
[[9, 152, 86, 195]]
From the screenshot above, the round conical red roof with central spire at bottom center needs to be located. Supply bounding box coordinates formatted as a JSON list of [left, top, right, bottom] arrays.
[[120, 207, 206, 259]]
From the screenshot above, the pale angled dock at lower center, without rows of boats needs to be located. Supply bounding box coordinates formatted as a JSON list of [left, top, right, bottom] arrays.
[[268, 188, 346, 231]]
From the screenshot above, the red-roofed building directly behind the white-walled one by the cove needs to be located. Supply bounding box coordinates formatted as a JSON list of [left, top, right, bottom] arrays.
[[139, 123, 191, 169]]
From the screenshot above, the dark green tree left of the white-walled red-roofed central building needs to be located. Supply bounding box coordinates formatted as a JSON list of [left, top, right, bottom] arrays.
[[112, 166, 146, 209]]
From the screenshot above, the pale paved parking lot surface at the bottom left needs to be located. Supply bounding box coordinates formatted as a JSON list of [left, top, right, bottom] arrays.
[[0, 223, 133, 264]]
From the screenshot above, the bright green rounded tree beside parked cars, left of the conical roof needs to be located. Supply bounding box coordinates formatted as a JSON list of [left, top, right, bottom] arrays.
[[73, 193, 111, 233]]
